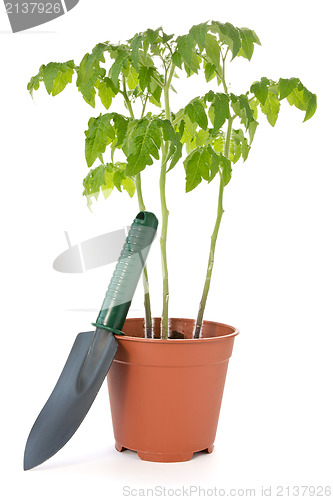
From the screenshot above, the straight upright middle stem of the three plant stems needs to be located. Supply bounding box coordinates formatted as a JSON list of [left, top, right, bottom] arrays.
[[160, 60, 175, 339]]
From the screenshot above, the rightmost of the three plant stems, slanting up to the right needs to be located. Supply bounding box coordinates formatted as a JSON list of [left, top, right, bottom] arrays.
[[193, 53, 234, 339]]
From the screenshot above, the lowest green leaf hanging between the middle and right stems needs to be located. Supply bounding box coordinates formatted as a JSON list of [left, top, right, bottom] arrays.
[[184, 146, 219, 193]]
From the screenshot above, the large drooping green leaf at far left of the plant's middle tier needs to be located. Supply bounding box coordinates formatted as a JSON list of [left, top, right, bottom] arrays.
[[85, 113, 115, 167]]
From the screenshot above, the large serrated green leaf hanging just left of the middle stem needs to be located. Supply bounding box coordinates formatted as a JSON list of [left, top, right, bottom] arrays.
[[126, 118, 162, 176]]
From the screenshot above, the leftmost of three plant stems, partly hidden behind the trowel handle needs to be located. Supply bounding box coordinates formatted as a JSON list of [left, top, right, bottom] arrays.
[[123, 75, 153, 338]]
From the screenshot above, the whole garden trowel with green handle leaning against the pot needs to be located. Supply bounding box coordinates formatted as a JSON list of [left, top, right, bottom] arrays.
[[24, 212, 158, 470]]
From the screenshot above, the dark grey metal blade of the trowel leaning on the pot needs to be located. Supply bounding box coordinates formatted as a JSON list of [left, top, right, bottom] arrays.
[[24, 328, 118, 470]]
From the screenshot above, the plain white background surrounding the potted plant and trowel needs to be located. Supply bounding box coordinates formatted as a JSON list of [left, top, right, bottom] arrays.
[[0, 0, 333, 500]]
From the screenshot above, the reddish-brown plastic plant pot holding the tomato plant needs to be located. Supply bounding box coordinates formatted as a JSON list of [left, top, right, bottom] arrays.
[[107, 318, 239, 462]]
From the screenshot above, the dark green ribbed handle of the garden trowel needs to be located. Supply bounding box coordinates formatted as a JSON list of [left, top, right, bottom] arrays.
[[93, 211, 158, 334]]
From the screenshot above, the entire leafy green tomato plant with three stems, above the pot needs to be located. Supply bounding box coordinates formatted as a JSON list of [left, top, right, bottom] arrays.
[[28, 21, 317, 338]]
